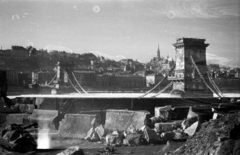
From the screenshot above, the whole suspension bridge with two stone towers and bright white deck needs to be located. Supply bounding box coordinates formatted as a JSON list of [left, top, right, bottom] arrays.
[[10, 38, 240, 99]]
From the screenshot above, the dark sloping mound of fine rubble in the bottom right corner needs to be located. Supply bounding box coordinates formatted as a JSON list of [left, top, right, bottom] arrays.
[[171, 112, 240, 155]]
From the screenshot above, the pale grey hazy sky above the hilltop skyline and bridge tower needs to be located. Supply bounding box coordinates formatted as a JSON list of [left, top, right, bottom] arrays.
[[0, 0, 240, 66]]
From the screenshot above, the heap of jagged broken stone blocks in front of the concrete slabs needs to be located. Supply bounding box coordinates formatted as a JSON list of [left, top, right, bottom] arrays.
[[85, 107, 189, 146]]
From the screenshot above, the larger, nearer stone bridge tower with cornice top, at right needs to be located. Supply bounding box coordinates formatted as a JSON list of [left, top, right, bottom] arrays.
[[168, 38, 213, 97]]
